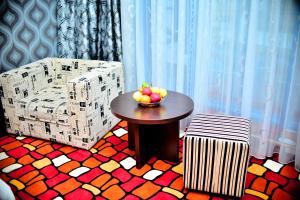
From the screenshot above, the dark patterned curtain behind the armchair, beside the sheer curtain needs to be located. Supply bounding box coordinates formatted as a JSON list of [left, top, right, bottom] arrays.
[[57, 0, 121, 61]]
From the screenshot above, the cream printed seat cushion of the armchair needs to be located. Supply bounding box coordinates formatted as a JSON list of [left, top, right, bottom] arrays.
[[17, 85, 70, 125]]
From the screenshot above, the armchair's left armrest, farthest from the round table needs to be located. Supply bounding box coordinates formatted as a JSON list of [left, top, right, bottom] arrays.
[[0, 59, 55, 133]]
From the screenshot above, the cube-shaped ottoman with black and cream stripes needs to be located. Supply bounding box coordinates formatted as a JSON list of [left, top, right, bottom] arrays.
[[183, 114, 250, 197]]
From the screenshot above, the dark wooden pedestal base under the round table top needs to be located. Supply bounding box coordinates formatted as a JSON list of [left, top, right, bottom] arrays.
[[128, 121, 179, 169]]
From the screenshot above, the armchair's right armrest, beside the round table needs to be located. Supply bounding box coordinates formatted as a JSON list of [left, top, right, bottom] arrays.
[[67, 62, 124, 144]]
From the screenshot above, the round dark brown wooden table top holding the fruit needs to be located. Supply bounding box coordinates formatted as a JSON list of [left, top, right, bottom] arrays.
[[110, 91, 194, 124]]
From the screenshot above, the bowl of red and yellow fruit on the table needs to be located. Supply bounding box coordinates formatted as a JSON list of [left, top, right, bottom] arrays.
[[132, 82, 168, 107]]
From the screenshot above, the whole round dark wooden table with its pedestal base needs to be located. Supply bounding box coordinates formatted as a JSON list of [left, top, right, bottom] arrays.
[[110, 91, 194, 168]]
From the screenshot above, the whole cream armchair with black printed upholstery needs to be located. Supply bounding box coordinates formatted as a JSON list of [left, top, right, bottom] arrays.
[[0, 58, 124, 149]]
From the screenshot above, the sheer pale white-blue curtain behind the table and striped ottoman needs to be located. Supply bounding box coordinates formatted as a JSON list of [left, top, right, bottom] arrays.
[[121, 0, 300, 171]]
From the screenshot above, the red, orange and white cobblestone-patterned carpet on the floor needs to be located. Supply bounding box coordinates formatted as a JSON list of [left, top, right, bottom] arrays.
[[0, 121, 300, 200]]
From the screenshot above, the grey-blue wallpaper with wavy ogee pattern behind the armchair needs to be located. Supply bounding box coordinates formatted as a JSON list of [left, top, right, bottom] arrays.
[[0, 0, 57, 72]]
